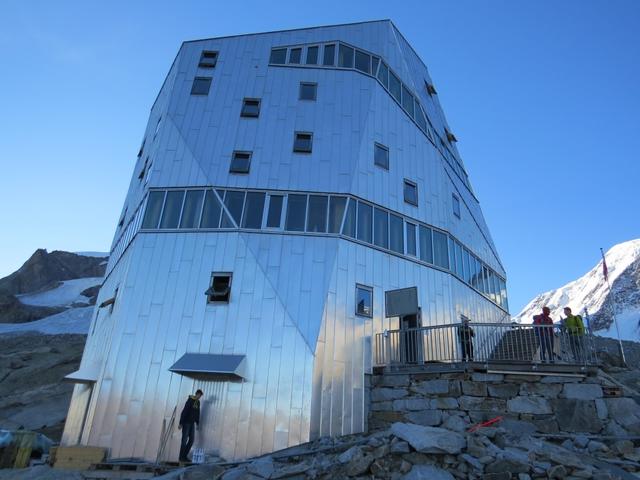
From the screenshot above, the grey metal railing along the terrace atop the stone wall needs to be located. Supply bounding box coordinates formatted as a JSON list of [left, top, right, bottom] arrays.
[[374, 323, 597, 366]]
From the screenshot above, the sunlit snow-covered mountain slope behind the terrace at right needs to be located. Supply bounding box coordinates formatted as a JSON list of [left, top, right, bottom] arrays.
[[514, 239, 640, 341]]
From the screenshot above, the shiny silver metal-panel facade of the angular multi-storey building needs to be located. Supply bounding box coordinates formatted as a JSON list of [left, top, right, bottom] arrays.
[[63, 21, 505, 460]]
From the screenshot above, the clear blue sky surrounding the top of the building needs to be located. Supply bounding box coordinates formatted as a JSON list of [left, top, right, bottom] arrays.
[[0, 0, 640, 314]]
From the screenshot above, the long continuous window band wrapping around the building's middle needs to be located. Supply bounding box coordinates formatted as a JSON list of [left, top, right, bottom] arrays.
[[142, 189, 507, 309]]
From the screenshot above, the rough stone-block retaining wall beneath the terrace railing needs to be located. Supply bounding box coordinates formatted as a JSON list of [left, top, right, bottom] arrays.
[[369, 373, 640, 436]]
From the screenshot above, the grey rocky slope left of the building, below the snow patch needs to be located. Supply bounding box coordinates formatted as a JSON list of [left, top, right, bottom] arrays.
[[0, 333, 86, 442]]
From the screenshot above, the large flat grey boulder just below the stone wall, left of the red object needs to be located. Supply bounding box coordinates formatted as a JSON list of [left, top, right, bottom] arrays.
[[391, 422, 467, 454]]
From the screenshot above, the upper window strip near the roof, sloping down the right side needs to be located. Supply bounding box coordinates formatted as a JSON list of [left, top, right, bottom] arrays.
[[269, 42, 471, 190]]
